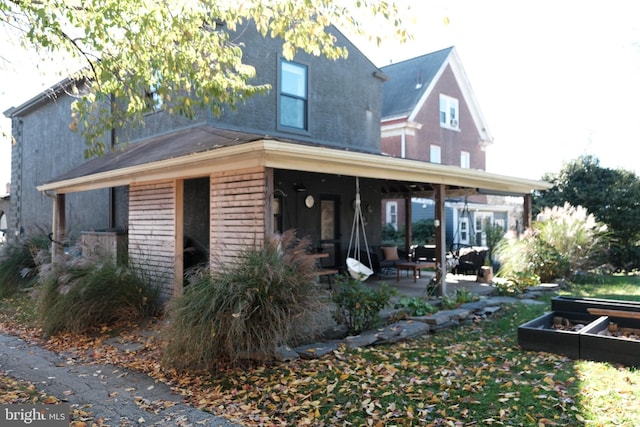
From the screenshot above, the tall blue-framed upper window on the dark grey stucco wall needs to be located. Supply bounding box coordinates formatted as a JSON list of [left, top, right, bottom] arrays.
[[278, 60, 308, 130]]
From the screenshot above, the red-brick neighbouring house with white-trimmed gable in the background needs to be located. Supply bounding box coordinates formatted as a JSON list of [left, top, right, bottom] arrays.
[[381, 47, 522, 251]]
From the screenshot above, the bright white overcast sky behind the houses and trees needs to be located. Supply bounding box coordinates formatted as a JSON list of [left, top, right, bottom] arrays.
[[0, 0, 640, 194]]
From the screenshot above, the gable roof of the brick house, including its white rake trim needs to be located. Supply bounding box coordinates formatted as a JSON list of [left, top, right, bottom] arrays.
[[381, 46, 493, 143]]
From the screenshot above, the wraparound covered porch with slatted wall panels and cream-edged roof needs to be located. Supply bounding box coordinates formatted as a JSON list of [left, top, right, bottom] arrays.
[[38, 126, 547, 298]]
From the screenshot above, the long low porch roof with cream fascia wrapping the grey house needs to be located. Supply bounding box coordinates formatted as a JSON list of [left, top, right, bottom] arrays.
[[37, 125, 550, 195]]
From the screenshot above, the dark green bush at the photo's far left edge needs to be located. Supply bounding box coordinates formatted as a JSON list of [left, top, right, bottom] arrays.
[[0, 233, 51, 298]]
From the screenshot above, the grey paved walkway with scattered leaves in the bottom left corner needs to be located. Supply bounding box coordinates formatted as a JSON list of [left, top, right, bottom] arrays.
[[0, 334, 241, 427]]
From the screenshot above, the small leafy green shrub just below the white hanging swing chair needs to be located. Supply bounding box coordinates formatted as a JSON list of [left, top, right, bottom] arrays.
[[332, 275, 395, 334]]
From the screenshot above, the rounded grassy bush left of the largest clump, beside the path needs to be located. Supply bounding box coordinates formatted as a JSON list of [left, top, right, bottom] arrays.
[[36, 258, 159, 334]]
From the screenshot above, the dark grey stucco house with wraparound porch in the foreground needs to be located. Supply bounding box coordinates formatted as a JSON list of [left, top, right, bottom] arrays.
[[5, 25, 546, 299]]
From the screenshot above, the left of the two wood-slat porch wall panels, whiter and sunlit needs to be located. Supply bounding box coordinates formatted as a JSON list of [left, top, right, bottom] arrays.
[[129, 181, 176, 301]]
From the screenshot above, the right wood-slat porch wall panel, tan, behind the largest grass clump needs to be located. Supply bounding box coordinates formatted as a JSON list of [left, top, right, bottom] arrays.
[[210, 168, 268, 266]]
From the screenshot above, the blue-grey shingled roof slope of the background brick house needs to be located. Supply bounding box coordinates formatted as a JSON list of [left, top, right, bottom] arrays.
[[380, 47, 453, 119]]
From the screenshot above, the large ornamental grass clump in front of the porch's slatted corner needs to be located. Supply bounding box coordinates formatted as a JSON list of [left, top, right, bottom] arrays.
[[164, 230, 326, 369]]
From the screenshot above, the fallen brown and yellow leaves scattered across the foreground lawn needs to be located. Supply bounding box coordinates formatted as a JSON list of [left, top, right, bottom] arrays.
[[0, 302, 640, 426]]
